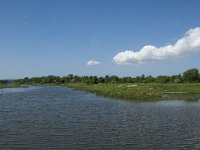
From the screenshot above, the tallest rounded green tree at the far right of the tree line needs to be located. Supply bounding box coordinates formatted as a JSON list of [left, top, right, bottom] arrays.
[[183, 68, 199, 83]]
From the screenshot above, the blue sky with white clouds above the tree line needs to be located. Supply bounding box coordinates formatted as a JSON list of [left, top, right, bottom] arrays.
[[0, 0, 200, 79]]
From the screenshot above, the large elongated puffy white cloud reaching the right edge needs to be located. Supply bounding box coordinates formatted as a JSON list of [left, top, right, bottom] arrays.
[[113, 27, 200, 64]]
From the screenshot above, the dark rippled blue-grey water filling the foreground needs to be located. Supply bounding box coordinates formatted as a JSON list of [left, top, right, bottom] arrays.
[[0, 87, 200, 150]]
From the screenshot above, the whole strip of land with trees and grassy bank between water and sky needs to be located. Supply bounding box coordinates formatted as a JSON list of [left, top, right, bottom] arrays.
[[0, 68, 200, 100]]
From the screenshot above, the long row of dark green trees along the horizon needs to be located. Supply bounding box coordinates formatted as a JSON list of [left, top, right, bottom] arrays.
[[15, 68, 200, 84]]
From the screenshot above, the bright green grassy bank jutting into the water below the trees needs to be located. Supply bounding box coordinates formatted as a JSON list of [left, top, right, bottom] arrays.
[[67, 83, 200, 100]]
